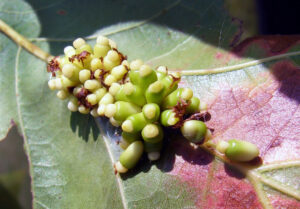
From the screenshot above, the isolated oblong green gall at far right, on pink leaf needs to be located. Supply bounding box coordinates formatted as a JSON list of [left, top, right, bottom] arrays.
[[225, 139, 259, 162]]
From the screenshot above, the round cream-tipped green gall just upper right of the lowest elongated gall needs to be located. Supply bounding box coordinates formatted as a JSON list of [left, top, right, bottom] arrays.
[[142, 124, 164, 143]]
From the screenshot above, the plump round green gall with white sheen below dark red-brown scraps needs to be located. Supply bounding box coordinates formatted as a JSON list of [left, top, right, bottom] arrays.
[[180, 120, 207, 144]]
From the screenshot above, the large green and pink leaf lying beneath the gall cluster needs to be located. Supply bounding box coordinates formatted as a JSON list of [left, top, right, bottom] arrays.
[[0, 0, 300, 208]]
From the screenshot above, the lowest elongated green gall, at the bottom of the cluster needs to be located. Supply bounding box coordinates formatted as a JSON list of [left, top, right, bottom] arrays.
[[120, 141, 144, 169]]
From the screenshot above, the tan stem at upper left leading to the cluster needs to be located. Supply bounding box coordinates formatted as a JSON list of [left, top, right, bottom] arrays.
[[0, 19, 53, 62]]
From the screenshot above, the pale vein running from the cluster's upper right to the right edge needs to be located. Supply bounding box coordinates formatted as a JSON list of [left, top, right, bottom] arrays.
[[180, 51, 300, 75]]
